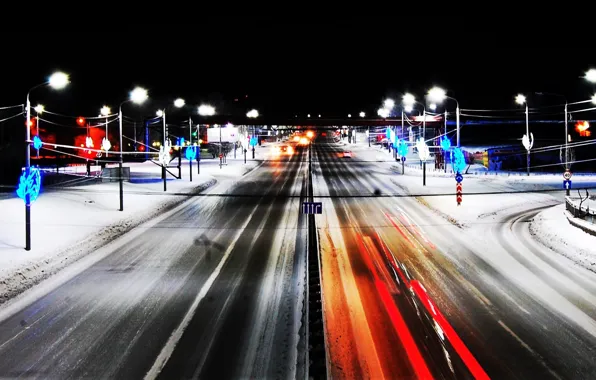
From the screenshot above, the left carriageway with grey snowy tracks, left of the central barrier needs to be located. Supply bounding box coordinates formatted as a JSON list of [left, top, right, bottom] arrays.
[[0, 148, 306, 379]]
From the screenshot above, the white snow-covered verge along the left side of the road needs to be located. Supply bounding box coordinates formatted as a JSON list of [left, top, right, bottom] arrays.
[[0, 157, 261, 303]]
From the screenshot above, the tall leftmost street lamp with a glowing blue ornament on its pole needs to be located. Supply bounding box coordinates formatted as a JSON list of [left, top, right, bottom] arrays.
[[21, 72, 69, 251]]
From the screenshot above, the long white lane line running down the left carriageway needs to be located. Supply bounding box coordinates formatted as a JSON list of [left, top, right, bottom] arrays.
[[145, 203, 259, 379]]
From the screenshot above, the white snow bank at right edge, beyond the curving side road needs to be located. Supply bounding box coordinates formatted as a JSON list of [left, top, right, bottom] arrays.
[[529, 204, 596, 272]]
